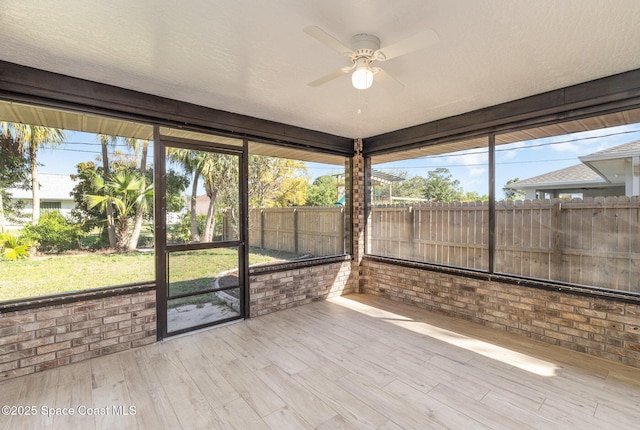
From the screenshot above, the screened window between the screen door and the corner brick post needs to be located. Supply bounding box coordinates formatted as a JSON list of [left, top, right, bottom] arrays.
[[248, 142, 350, 264]]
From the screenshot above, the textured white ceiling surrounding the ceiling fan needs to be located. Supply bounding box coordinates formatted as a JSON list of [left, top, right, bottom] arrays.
[[0, 0, 640, 137]]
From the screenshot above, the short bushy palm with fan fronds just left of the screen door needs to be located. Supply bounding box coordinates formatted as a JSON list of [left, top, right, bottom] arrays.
[[85, 170, 153, 251]]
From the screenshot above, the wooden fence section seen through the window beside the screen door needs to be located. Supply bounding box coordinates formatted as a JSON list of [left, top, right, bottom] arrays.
[[249, 206, 347, 257]]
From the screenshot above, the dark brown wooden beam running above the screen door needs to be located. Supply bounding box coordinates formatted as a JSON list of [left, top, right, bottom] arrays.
[[0, 61, 353, 156]]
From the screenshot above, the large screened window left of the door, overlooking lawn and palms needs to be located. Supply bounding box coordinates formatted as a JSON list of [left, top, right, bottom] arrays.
[[0, 102, 155, 301]]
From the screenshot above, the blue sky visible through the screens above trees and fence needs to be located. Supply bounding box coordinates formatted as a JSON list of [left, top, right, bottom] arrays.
[[38, 124, 640, 198]]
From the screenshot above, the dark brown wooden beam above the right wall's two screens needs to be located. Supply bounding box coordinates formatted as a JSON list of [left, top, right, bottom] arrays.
[[364, 69, 640, 156]]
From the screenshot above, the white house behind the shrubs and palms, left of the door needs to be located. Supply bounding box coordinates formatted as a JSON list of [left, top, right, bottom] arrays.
[[7, 173, 77, 229]]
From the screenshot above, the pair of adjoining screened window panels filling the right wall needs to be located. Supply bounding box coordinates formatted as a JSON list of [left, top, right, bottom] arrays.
[[367, 109, 640, 294]]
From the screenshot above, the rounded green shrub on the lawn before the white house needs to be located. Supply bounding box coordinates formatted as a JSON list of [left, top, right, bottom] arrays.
[[22, 211, 83, 253]]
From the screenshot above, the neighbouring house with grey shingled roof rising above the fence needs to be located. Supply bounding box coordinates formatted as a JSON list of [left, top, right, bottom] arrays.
[[506, 140, 640, 199]]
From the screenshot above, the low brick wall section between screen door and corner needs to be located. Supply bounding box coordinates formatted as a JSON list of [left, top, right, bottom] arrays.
[[249, 261, 358, 318]]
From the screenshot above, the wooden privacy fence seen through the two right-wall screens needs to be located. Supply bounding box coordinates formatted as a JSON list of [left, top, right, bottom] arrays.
[[369, 197, 640, 292]]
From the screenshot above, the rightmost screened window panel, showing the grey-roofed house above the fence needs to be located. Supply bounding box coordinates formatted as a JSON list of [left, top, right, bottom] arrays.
[[495, 110, 640, 293]]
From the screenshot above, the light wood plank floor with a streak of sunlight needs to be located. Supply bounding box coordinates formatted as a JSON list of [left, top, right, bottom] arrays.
[[0, 295, 640, 430]]
